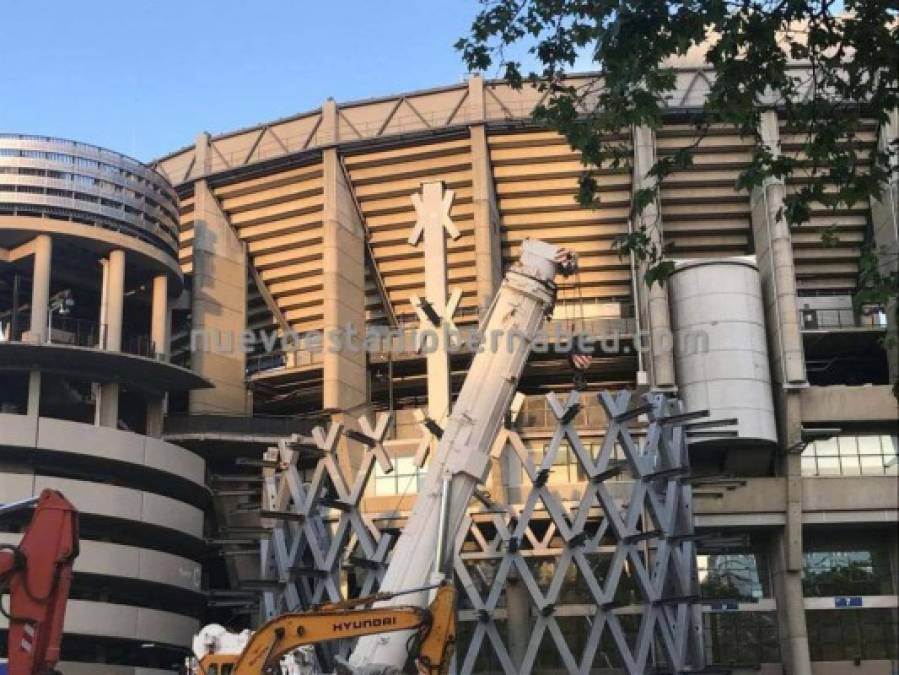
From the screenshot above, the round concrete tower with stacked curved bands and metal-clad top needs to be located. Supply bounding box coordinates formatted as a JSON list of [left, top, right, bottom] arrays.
[[0, 135, 207, 675]]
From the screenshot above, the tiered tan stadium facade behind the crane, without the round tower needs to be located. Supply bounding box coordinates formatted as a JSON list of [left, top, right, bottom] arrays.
[[0, 63, 899, 675]]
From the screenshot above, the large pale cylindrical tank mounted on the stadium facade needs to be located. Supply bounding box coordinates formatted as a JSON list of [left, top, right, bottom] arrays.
[[668, 256, 777, 443]]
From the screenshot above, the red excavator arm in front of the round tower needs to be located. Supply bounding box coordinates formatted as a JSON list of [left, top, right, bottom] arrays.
[[0, 490, 78, 675]]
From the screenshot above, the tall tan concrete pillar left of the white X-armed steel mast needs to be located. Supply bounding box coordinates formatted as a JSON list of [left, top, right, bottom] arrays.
[[322, 147, 368, 470]]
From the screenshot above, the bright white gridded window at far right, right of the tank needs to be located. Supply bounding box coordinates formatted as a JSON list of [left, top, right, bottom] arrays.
[[802, 434, 899, 476]]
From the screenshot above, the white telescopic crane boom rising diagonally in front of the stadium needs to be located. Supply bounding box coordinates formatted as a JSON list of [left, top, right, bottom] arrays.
[[349, 239, 575, 671]]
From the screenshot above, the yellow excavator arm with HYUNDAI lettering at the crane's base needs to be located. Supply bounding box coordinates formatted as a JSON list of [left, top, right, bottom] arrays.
[[192, 582, 456, 675]]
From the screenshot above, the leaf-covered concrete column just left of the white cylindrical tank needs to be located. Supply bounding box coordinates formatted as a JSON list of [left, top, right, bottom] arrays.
[[632, 126, 677, 390]]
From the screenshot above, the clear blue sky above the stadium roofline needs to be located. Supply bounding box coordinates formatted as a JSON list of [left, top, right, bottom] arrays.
[[0, 0, 497, 161]]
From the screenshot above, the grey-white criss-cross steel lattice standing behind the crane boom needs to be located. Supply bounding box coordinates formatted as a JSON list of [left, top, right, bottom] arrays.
[[255, 391, 707, 675]]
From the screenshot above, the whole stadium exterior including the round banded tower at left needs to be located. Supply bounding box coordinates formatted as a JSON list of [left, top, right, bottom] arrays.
[[0, 63, 899, 675]]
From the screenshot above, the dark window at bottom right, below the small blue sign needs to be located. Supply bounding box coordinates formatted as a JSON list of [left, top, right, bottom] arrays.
[[805, 609, 897, 661]]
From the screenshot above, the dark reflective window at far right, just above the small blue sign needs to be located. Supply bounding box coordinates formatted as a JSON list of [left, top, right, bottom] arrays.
[[802, 541, 893, 598]]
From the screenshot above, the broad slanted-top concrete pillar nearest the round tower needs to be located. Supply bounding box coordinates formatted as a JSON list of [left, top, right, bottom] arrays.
[[190, 180, 250, 415]]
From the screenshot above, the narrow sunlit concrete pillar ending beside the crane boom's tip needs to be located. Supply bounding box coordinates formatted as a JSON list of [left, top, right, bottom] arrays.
[[468, 75, 503, 317]]
